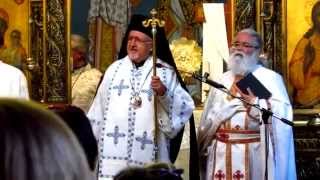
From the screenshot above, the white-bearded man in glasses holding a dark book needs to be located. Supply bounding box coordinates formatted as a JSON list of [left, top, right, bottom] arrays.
[[198, 28, 296, 180]]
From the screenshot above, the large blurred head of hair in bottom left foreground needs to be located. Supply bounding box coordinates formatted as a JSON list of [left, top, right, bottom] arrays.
[[0, 98, 93, 180]]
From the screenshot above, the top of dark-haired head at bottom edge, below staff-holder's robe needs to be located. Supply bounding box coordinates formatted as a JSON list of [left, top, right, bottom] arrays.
[[114, 163, 183, 180]]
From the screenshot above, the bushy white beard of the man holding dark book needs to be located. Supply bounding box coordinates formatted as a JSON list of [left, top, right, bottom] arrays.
[[228, 51, 259, 76]]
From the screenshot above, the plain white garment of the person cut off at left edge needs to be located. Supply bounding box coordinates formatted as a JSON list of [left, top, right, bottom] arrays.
[[0, 61, 29, 99]]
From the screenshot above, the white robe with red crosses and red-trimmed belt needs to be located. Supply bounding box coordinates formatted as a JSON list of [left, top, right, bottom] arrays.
[[198, 66, 296, 180]]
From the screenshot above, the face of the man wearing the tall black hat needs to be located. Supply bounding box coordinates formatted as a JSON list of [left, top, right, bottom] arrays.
[[127, 31, 152, 63]]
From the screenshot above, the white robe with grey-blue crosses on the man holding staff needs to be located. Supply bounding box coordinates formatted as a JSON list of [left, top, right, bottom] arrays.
[[88, 56, 194, 180]]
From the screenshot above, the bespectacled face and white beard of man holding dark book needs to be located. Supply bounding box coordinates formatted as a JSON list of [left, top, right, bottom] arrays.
[[228, 33, 259, 75]]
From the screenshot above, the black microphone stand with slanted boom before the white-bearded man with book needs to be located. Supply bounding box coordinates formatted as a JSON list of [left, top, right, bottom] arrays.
[[192, 72, 294, 180]]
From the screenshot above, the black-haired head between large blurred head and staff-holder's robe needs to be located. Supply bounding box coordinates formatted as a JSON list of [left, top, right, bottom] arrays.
[[49, 105, 98, 171]]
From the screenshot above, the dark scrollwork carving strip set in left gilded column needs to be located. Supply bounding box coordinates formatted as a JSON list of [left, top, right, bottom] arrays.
[[45, 0, 69, 103]]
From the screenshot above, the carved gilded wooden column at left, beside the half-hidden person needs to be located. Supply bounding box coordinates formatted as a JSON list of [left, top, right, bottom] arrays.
[[29, 0, 71, 104]]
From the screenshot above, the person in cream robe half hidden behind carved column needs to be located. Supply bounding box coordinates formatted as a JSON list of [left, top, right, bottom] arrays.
[[71, 34, 102, 113]]
